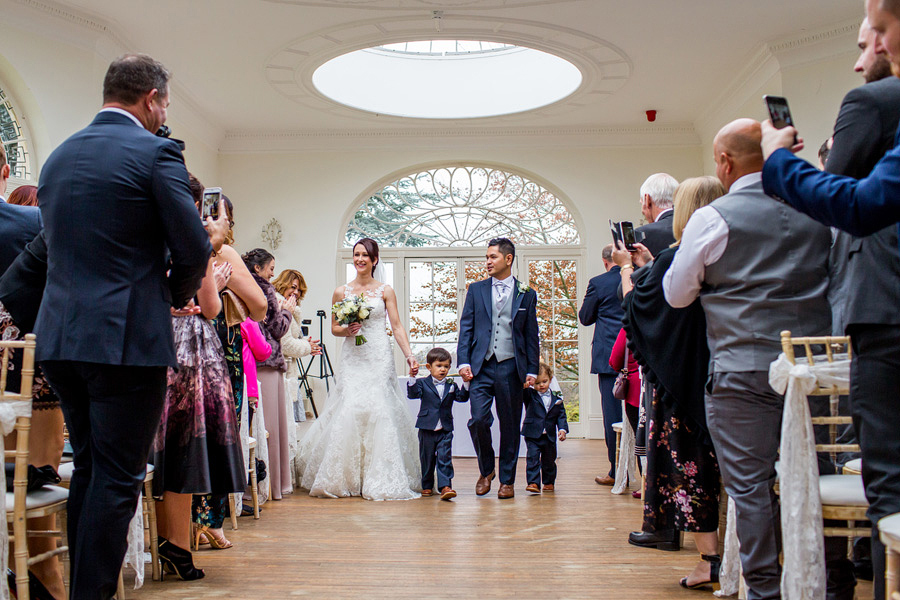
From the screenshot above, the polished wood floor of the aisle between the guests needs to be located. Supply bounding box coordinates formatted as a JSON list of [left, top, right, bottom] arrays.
[[126, 440, 871, 600]]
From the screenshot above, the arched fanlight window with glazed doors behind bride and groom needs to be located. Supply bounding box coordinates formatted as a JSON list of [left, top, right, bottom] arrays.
[[341, 164, 590, 422]]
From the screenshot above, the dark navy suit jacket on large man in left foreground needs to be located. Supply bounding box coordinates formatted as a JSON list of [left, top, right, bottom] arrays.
[[35, 112, 212, 366]]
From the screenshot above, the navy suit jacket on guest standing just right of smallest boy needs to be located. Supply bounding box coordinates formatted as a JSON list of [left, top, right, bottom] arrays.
[[578, 265, 624, 375]]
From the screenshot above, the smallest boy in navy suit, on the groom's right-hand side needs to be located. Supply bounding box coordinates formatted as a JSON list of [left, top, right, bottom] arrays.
[[522, 363, 569, 494]]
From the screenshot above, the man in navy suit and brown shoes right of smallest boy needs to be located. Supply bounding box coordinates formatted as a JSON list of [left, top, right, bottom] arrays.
[[578, 244, 624, 485]]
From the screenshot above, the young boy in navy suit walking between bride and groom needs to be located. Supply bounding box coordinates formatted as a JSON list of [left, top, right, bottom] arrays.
[[406, 348, 469, 500]]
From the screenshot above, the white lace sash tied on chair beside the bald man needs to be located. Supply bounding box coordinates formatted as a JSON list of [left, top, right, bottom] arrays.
[[769, 353, 850, 600]]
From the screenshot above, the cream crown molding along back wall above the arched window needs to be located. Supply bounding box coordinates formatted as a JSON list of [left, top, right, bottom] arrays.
[[219, 124, 699, 154]]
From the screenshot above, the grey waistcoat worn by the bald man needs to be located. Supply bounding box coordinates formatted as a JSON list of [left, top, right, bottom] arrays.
[[700, 183, 831, 373]]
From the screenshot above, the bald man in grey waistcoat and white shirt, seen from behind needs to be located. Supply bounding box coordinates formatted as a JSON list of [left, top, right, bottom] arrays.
[[663, 119, 831, 600]]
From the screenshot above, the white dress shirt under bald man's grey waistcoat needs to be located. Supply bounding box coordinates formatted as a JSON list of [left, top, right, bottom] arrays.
[[663, 172, 762, 308]]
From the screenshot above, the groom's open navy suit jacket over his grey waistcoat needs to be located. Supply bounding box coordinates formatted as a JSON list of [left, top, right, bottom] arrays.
[[456, 278, 541, 381]]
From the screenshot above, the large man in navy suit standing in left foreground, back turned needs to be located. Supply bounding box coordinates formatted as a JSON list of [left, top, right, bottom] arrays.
[[35, 55, 225, 599]]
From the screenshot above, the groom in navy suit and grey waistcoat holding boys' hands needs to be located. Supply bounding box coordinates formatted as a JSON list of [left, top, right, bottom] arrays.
[[457, 238, 540, 499]]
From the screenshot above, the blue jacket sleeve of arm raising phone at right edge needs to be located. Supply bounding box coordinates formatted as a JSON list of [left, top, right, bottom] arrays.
[[763, 130, 900, 237]]
